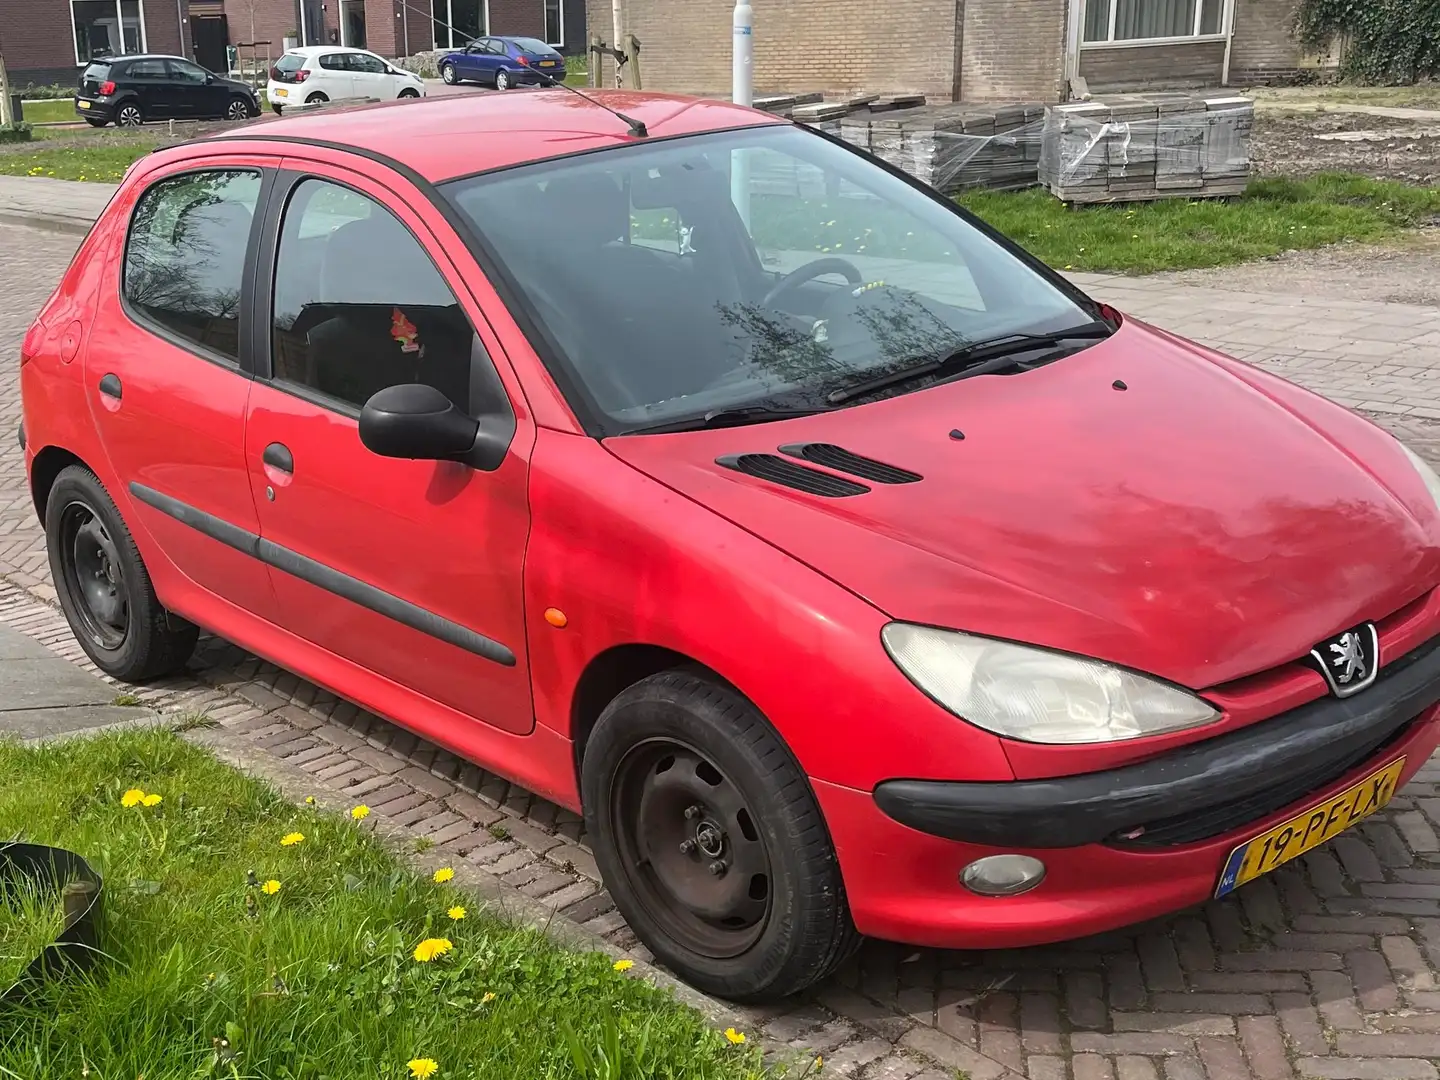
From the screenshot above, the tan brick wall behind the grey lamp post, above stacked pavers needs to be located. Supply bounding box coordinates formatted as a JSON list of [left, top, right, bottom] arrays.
[[584, 0, 967, 101]]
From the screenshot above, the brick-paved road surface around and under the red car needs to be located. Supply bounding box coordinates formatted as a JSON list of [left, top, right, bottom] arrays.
[[8, 225, 1440, 1080]]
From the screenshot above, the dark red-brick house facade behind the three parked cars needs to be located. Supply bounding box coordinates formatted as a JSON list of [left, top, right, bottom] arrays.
[[0, 0, 586, 88]]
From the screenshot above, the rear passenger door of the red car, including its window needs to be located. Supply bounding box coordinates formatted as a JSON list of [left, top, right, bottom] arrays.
[[84, 158, 276, 618]]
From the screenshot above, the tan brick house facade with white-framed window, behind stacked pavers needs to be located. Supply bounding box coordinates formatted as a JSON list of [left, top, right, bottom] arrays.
[[588, 0, 1312, 102]]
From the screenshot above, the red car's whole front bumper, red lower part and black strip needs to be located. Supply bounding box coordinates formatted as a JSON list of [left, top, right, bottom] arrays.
[[812, 639, 1440, 949]]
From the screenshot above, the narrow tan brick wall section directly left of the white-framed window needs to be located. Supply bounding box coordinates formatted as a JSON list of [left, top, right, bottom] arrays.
[[960, 0, 1066, 102]]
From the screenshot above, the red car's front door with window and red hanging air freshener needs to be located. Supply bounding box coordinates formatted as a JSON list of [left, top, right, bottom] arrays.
[[245, 161, 533, 733]]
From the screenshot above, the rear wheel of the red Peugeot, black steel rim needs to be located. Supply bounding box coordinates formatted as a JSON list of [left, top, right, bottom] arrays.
[[45, 465, 200, 683]]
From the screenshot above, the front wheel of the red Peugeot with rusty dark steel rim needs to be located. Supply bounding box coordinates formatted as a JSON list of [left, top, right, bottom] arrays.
[[582, 670, 860, 1002]]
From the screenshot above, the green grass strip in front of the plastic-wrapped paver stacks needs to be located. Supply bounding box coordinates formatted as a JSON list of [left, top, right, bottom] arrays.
[[959, 174, 1440, 274]]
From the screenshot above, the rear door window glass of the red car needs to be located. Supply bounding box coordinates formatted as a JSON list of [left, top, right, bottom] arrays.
[[122, 170, 261, 363]]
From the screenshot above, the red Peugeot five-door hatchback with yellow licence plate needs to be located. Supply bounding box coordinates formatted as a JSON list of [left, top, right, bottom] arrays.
[[20, 89, 1440, 999]]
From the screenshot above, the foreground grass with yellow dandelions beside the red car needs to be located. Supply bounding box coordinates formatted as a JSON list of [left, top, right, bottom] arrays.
[[0, 732, 763, 1080]]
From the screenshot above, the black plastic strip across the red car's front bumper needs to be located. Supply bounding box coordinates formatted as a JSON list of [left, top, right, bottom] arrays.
[[876, 638, 1440, 848]]
